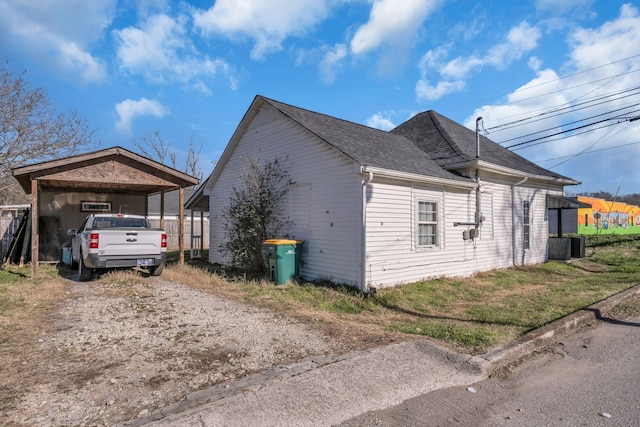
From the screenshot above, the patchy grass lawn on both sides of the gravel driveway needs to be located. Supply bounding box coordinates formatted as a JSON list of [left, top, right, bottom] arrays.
[[0, 235, 640, 354]]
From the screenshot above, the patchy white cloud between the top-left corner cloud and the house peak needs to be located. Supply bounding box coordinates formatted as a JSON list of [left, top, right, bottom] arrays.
[[114, 15, 237, 93]]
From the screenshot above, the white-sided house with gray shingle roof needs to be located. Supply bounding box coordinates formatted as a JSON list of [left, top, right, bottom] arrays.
[[203, 96, 579, 291]]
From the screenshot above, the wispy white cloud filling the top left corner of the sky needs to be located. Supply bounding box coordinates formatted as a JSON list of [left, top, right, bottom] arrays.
[[0, 0, 117, 82]]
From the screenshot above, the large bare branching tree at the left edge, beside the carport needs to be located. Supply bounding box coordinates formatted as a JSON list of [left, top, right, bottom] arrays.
[[0, 63, 95, 204]]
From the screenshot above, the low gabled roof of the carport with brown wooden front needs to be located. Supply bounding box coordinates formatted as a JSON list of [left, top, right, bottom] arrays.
[[12, 147, 198, 195]]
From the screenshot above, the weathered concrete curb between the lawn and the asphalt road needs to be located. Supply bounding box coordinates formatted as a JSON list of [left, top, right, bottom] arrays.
[[479, 285, 640, 371]]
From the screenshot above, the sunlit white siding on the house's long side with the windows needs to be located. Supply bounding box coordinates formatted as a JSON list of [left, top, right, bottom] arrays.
[[365, 177, 564, 287]]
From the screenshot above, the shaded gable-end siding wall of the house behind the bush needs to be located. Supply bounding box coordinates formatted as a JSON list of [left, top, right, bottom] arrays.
[[209, 107, 362, 286]]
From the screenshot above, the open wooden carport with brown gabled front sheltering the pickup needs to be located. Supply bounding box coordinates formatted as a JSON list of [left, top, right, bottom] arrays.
[[12, 147, 198, 277]]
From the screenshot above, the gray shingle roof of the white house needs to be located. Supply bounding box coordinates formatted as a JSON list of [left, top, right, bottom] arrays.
[[257, 96, 569, 181]]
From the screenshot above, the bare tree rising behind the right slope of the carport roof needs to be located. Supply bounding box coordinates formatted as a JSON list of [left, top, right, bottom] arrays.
[[133, 131, 203, 179]]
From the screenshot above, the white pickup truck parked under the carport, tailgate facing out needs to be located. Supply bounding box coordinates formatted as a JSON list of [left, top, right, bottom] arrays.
[[68, 214, 167, 282]]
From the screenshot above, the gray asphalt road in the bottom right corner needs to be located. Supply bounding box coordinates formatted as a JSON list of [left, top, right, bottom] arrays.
[[341, 299, 640, 427]]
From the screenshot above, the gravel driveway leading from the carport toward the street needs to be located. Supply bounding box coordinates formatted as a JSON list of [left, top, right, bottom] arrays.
[[3, 278, 344, 425]]
